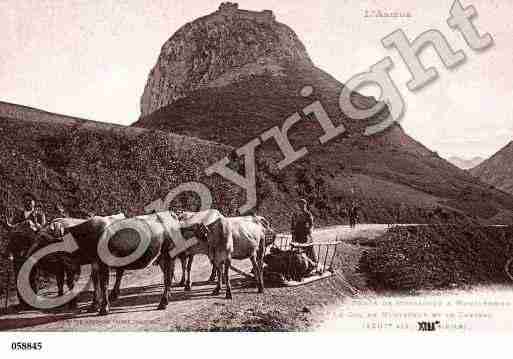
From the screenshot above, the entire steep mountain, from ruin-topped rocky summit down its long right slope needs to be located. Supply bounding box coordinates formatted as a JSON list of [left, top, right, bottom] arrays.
[[133, 4, 513, 222]]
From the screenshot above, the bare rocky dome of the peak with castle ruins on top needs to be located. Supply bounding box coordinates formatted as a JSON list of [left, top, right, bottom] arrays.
[[141, 2, 312, 116]]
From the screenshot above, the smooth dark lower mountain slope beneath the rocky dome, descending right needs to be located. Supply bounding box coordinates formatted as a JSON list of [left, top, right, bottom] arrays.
[[134, 64, 513, 222]]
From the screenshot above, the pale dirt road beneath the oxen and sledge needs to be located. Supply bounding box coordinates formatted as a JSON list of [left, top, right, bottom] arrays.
[[0, 225, 386, 331]]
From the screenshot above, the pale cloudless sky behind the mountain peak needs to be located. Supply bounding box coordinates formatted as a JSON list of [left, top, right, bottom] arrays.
[[0, 0, 513, 157]]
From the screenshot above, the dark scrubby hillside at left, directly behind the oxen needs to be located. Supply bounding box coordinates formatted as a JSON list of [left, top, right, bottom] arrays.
[[0, 119, 243, 216]]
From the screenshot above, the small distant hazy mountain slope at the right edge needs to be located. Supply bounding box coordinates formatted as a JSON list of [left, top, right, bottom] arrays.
[[470, 142, 513, 194]]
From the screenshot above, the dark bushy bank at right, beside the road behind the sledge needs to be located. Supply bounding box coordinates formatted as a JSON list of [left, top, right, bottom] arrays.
[[359, 224, 513, 291]]
